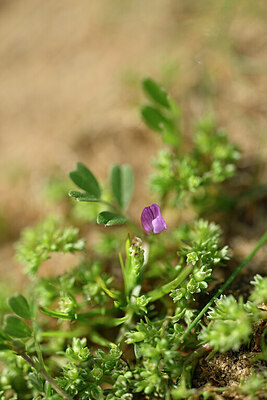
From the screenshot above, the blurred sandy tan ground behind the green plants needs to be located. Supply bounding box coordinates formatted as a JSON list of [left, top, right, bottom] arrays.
[[0, 0, 267, 286]]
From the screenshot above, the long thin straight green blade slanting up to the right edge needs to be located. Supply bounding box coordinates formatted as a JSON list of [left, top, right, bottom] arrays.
[[181, 231, 267, 342]]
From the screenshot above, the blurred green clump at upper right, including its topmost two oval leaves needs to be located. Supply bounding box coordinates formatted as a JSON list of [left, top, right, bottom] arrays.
[[146, 89, 240, 207]]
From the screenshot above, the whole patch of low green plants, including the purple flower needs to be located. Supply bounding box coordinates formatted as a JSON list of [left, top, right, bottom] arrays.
[[0, 79, 267, 400]]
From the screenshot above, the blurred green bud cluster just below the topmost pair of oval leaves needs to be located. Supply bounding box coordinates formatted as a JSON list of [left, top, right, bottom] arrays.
[[151, 111, 240, 207]]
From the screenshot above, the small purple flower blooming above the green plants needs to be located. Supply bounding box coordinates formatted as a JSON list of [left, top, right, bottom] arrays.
[[141, 204, 167, 233]]
